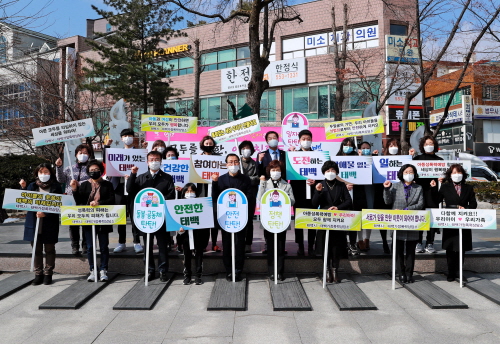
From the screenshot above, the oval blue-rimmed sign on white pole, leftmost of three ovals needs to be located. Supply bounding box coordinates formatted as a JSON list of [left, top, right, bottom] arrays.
[[133, 188, 165, 287]]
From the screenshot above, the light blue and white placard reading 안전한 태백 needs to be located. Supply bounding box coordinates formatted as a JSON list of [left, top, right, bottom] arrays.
[[166, 197, 214, 232]]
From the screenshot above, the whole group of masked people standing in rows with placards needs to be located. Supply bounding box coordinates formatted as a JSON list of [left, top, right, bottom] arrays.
[[20, 129, 477, 285]]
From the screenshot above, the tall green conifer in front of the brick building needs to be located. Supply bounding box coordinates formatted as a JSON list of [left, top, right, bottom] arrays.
[[81, 0, 182, 114]]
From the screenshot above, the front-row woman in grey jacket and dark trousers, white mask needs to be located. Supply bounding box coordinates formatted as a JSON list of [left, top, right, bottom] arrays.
[[384, 164, 425, 283]]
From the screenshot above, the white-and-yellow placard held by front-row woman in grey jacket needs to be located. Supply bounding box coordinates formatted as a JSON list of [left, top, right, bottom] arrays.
[[361, 209, 430, 231]]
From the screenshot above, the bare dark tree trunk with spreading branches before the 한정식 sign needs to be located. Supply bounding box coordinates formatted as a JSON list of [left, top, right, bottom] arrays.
[[166, 0, 302, 114]]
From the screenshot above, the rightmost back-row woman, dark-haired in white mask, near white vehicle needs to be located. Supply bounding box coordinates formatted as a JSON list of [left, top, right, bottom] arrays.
[[409, 135, 443, 253]]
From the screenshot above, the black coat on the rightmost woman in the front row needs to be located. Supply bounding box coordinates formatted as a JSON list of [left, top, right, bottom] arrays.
[[434, 182, 477, 252]]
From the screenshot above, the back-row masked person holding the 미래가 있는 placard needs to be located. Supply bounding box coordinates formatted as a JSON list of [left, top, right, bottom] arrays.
[[103, 128, 145, 254]]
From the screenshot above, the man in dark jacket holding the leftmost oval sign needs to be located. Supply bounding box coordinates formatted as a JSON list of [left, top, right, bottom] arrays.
[[127, 151, 175, 282]]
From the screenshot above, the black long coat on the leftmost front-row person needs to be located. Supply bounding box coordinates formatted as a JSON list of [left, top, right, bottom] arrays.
[[23, 183, 63, 244]]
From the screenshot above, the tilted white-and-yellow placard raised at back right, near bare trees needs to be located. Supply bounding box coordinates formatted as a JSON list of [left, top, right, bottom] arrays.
[[325, 115, 384, 140]]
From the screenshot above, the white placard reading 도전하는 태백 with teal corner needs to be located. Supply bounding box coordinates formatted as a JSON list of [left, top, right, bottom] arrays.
[[286, 151, 330, 180]]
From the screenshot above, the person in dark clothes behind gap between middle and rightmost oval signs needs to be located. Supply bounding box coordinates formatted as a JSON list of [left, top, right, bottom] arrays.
[[238, 141, 259, 253]]
